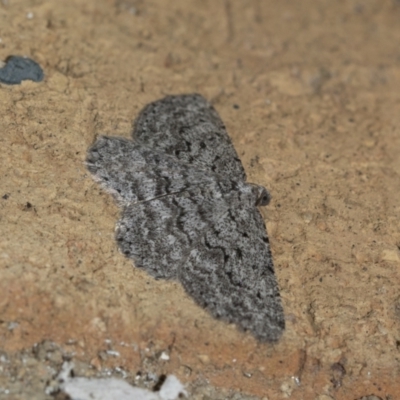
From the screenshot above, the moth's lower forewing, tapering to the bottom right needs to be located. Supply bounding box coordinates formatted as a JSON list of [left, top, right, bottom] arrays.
[[179, 191, 285, 341]]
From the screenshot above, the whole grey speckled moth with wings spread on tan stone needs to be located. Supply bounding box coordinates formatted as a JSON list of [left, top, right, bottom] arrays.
[[86, 94, 285, 341]]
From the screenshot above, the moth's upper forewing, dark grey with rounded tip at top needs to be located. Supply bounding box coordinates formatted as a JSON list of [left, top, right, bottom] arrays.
[[133, 94, 246, 180]]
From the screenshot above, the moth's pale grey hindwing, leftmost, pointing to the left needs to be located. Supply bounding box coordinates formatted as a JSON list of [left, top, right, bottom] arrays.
[[86, 136, 213, 205]]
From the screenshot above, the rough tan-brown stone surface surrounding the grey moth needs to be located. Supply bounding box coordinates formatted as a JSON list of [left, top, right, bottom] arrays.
[[0, 0, 400, 400]]
